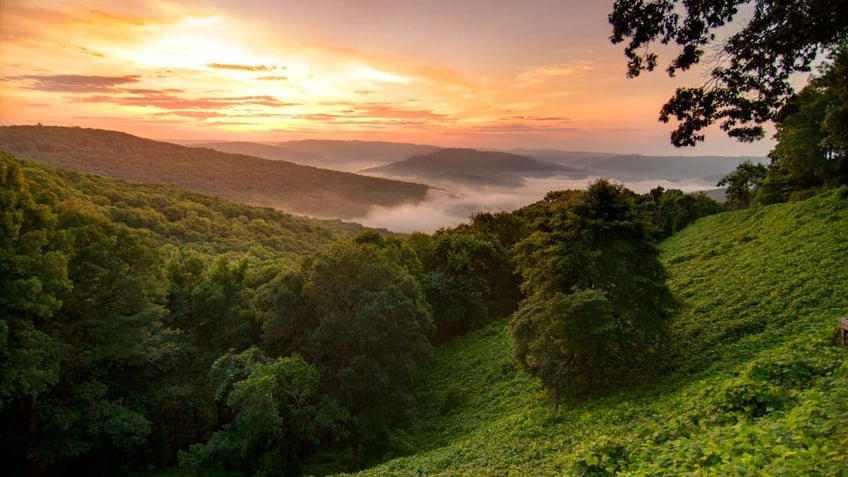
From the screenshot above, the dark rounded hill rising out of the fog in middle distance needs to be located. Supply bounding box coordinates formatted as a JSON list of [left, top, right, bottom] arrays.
[[362, 148, 585, 187]]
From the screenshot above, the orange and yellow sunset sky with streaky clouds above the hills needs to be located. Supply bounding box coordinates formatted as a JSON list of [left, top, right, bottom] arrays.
[[0, 0, 773, 156]]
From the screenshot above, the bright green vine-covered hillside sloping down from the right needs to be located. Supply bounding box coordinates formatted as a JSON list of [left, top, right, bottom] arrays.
[[348, 188, 848, 476]]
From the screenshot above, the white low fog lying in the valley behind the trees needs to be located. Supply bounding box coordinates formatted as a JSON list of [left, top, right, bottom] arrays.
[[354, 176, 715, 233]]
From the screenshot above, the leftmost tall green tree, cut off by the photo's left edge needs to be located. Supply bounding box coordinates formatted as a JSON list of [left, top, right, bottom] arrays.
[[0, 152, 71, 411]]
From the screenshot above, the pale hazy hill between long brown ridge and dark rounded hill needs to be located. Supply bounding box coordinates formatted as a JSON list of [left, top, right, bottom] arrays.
[[279, 139, 440, 172]]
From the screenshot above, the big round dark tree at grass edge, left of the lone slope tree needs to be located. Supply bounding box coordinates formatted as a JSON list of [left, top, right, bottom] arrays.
[[264, 233, 432, 458]]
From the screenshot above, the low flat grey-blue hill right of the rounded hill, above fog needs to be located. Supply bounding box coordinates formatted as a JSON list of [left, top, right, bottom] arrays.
[[516, 149, 765, 182]]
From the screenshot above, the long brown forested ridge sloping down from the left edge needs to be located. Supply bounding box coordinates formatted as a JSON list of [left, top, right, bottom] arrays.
[[0, 126, 429, 219]]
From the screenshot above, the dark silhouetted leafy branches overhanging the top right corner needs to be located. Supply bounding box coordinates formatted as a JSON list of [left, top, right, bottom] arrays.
[[609, 0, 848, 147]]
